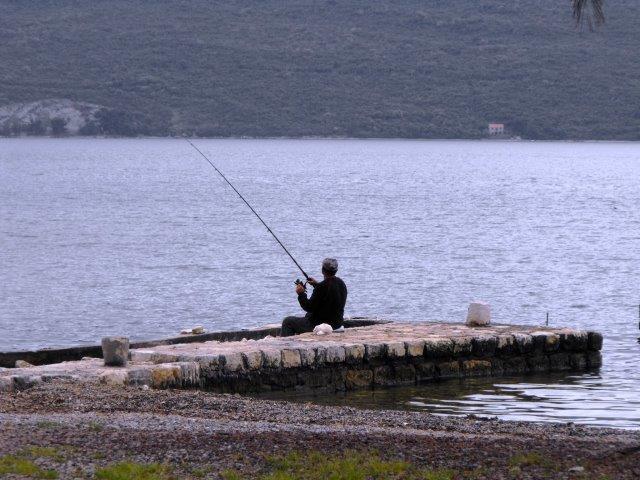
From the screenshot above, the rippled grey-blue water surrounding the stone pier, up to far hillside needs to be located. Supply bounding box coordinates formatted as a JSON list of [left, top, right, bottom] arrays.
[[0, 139, 640, 428]]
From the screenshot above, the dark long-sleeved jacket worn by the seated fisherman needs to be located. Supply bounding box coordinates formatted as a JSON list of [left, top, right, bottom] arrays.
[[298, 277, 347, 328]]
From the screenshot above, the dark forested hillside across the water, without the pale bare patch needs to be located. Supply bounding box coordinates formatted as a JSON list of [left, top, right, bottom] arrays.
[[0, 0, 640, 139]]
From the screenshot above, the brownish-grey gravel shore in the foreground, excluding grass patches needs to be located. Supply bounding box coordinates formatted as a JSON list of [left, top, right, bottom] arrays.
[[0, 383, 640, 480]]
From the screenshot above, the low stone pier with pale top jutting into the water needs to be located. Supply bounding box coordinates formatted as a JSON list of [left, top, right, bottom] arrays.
[[0, 322, 602, 393]]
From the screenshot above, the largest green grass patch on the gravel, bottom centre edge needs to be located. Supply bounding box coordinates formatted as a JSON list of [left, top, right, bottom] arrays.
[[222, 452, 455, 480]]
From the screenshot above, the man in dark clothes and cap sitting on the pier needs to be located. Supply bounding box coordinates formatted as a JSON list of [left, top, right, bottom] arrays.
[[282, 258, 347, 337]]
